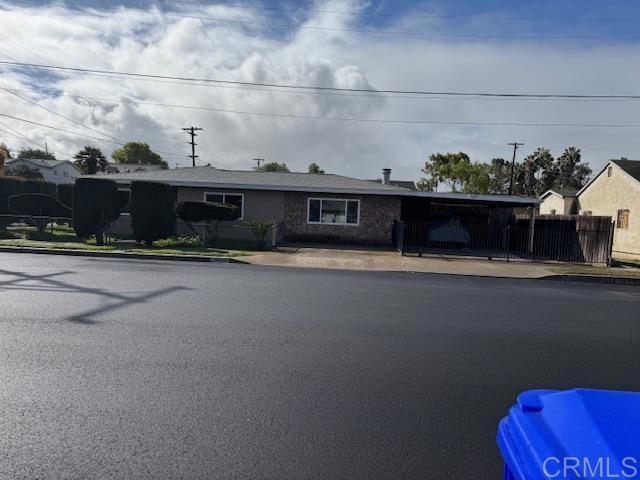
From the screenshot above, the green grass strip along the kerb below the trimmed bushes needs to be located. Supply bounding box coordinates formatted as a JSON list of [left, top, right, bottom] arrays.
[[0, 226, 248, 257]]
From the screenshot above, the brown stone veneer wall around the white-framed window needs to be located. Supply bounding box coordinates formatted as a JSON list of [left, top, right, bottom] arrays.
[[284, 192, 401, 245]]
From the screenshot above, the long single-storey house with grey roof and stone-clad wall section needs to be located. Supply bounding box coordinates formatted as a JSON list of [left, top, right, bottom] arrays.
[[90, 166, 539, 245]]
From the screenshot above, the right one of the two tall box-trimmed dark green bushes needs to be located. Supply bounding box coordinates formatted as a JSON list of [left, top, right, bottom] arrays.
[[129, 181, 175, 245]]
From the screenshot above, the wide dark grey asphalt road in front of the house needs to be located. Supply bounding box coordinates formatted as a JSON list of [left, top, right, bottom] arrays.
[[0, 254, 640, 480]]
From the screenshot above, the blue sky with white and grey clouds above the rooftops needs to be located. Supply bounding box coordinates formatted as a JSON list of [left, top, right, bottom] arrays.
[[0, 0, 640, 179]]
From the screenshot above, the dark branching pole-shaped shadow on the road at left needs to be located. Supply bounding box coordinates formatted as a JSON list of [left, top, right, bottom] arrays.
[[0, 269, 191, 325]]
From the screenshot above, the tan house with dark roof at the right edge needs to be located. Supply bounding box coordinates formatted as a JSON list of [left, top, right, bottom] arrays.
[[578, 160, 640, 259]]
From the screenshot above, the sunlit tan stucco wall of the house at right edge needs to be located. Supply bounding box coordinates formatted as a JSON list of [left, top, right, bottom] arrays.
[[578, 163, 640, 259]]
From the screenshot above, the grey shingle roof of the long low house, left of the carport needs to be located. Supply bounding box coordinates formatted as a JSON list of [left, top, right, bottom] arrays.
[[89, 166, 407, 195]]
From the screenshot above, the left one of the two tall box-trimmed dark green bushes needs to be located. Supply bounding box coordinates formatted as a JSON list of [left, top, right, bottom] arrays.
[[72, 178, 120, 245]]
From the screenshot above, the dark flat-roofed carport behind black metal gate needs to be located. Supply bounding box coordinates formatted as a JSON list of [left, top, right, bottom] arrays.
[[394, 192, 540, 258]]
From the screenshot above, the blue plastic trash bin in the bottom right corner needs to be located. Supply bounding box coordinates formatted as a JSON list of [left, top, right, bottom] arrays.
[[498, 388, 640, 480]]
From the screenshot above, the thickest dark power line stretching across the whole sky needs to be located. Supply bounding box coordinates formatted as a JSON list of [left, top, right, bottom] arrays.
[[0, 60, 640, 100]]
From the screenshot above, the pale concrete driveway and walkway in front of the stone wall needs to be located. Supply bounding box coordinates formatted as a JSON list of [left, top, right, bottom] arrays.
[[242, 247, 553, 278]]
